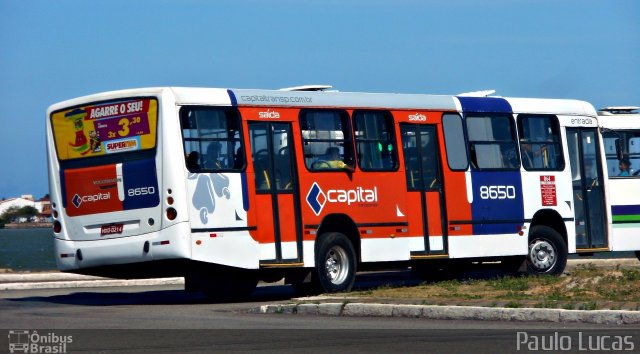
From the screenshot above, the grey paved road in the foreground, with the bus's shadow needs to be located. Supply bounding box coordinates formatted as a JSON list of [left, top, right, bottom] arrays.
[[0, 258, 640, 354]]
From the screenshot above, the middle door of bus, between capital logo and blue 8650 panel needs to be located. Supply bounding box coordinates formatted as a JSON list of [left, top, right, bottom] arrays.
[[400, 124, 447, 257]]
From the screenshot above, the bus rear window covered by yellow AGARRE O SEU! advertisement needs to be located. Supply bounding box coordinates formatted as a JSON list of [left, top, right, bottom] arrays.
[[51, 98, 158, 161]]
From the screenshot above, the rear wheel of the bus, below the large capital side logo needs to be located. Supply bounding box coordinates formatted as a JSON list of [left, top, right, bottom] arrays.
[[312, 232, 356, 293]]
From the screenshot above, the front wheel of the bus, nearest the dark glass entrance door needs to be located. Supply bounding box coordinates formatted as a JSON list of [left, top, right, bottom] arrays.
[[527, 225, 568, 275]]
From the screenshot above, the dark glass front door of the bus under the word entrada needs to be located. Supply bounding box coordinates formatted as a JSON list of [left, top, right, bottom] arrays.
[[567, 128, 608, 252]]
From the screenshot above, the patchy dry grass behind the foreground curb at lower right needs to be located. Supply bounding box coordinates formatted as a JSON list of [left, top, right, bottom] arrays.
[[354, 264, 640, 310]]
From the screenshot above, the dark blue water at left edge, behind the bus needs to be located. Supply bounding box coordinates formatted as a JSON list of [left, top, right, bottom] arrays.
[[0, 228, 56, 272]]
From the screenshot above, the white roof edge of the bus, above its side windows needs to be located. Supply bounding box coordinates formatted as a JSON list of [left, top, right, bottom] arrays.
[[48, 85, 596, 116]]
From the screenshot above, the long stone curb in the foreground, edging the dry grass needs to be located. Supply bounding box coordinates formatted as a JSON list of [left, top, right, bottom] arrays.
[[250, 303, 640, 325]]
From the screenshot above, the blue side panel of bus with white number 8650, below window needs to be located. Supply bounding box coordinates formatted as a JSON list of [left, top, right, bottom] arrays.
[[471, 171, 524, 235]]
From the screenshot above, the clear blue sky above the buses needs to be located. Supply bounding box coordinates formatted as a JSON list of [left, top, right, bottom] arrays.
[[0, 0, 640, 199]]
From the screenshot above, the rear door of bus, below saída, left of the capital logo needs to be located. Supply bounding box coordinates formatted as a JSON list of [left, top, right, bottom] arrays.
[[249, 122, 302, 265]]
